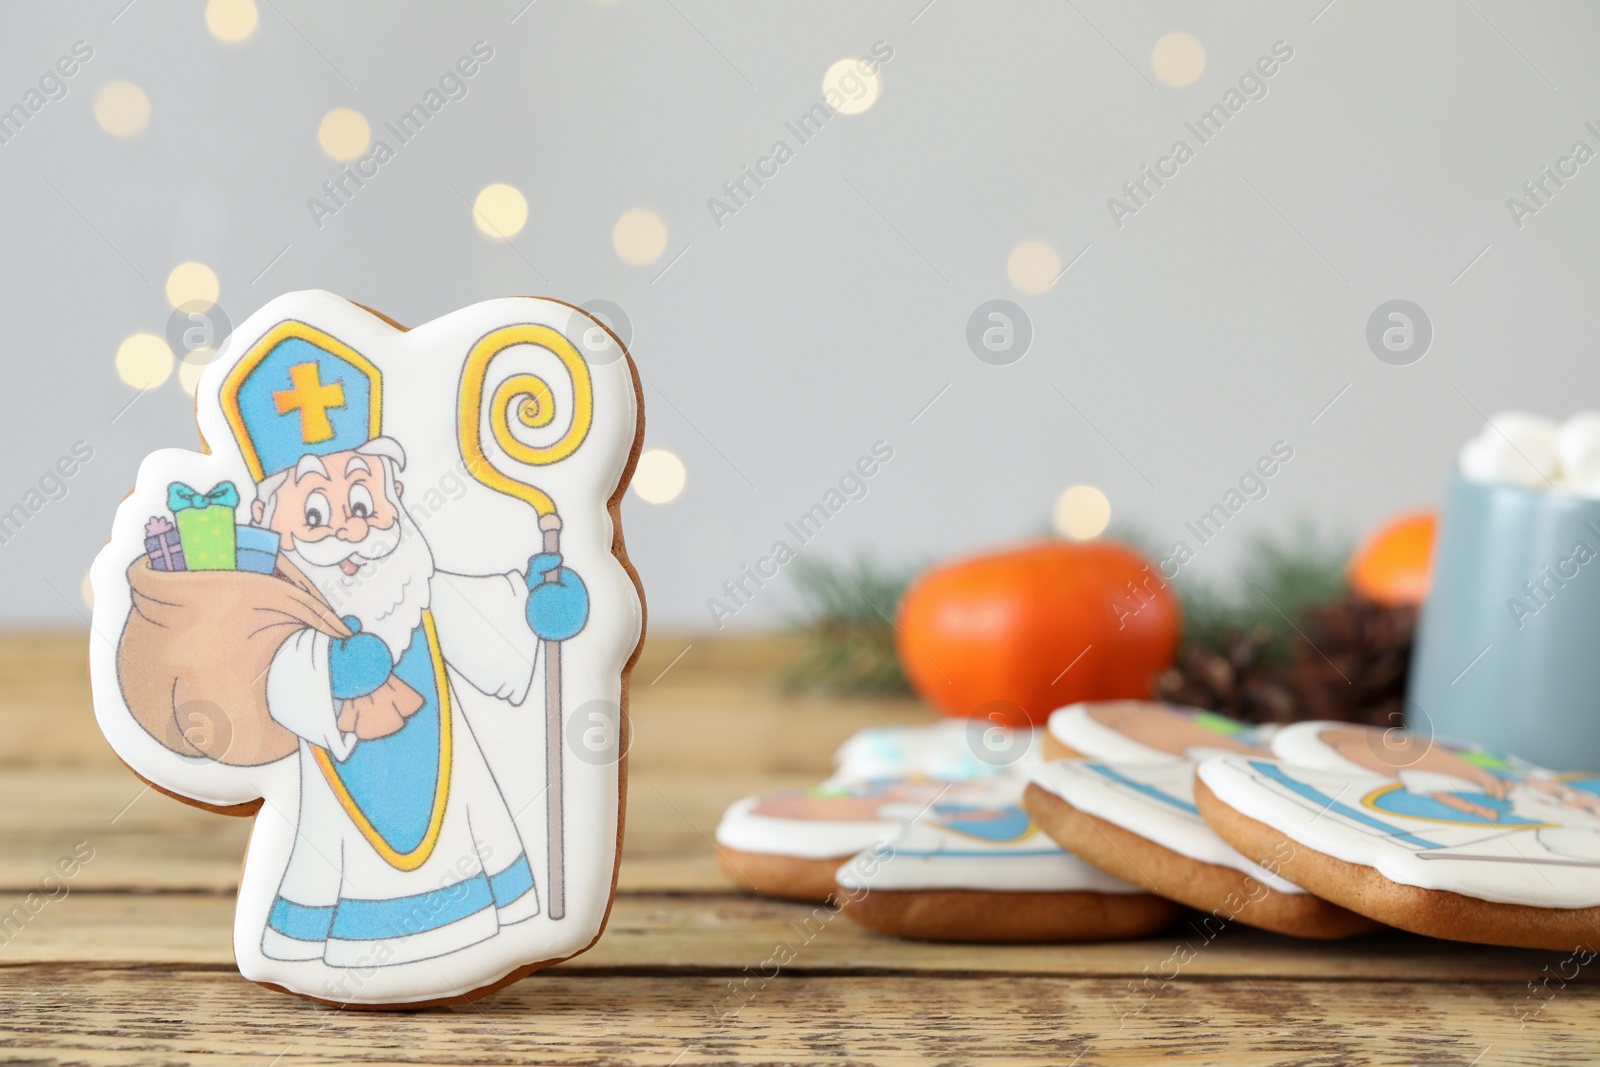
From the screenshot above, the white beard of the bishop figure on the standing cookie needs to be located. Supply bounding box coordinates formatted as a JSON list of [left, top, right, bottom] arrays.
[[283, 507, 434, 662]]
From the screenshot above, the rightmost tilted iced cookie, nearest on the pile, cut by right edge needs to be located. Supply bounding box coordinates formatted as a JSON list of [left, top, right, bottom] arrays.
[[1195, 757, 1600, 950]]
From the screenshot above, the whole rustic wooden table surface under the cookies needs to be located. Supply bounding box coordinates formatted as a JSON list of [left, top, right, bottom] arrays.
[[0, 635, 1600, 1067]]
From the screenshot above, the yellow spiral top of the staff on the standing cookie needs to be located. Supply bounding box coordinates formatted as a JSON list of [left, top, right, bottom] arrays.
[[458, 323, 594, 515]]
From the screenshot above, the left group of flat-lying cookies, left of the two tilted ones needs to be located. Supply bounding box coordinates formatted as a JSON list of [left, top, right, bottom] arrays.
[[717, 720, 1179, 942]]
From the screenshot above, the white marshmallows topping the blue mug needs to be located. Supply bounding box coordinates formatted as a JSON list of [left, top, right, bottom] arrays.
[[1461, 411, 1600, 498]]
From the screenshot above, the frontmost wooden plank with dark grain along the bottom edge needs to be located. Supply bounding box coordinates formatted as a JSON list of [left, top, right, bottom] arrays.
[[0, 966, 1600, 1067]]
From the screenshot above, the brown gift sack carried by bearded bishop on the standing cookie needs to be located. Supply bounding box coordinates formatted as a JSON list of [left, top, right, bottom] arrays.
[[117, 557, 422, 766]]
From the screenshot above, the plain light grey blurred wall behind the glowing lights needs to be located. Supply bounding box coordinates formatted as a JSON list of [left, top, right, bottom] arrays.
[[0, 0, 1600, 629]]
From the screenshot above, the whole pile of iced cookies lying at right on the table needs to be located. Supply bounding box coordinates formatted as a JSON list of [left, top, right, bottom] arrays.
[[717, 701, 1600, 950]]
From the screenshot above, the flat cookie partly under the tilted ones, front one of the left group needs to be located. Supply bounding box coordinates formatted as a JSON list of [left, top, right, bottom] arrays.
[[835, 790, 1179, 944]]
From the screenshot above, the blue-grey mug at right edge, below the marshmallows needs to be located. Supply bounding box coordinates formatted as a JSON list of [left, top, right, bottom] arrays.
[[1406, 474, 1600, 771]]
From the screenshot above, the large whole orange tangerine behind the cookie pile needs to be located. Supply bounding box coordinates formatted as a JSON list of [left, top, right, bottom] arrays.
[[894, 541, 1181, 726]]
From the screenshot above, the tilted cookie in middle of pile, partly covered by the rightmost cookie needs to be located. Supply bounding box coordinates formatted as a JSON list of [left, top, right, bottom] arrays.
[[1022, 701, 1378, 937]]
